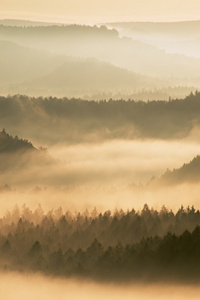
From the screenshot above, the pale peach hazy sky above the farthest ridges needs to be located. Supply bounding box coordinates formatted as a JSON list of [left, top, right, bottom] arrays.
[[0, 0, 200, 23]]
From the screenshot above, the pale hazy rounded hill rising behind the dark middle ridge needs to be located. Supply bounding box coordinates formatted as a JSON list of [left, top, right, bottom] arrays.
[[27, 59, 160, 95]]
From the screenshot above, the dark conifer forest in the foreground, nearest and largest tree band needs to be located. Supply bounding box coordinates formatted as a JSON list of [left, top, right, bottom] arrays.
[[0, 204, 200, 280]]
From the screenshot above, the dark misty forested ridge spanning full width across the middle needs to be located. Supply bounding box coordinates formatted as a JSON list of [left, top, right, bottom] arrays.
[[0, 93, 200, 143]]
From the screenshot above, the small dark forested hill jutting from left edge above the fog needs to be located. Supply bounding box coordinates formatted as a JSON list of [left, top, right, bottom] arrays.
[[0, 129, 36, 154]]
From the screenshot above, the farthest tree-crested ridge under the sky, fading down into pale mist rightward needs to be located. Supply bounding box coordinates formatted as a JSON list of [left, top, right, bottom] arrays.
[[0, 25, 200, 79]]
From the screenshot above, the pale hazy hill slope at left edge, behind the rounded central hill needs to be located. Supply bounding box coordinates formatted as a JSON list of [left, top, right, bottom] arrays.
[[0, 41, 64, 86]]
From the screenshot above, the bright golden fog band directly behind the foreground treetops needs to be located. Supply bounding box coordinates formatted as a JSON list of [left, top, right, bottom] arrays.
[[0, 183, 200, 219]]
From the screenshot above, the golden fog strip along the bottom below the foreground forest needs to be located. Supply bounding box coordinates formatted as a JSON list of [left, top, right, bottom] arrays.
[[0, 273, 200, 300]]
